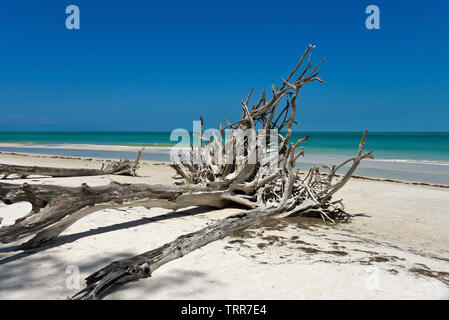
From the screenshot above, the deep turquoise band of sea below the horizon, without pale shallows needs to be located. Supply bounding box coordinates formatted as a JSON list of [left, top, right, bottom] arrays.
[[0, 132, 449, 163]]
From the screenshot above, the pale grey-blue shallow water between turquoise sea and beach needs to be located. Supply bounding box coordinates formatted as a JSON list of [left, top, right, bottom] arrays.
[[0, 143, 449, 186]]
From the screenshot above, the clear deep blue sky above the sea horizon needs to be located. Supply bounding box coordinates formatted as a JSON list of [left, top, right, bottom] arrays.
[[0, 0, 449, 131]]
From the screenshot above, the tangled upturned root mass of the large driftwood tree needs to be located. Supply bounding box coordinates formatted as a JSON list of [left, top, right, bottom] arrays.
[[172, 45, 372, 221]]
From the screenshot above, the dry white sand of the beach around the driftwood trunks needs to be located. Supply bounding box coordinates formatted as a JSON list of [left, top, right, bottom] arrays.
[[0, 153, 449, 299]]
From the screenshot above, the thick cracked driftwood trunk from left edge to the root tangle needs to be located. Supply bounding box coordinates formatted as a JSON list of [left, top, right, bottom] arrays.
[[0, 182, 229, 249]]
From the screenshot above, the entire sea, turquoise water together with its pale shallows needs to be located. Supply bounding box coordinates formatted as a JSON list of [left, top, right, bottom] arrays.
[[0, 132, 449, 185]]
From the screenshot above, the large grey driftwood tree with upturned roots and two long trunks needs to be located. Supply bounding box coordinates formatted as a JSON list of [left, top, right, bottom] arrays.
[[0, 45, 372, 299]]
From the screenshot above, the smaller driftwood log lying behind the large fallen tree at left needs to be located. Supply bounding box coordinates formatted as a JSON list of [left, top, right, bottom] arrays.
[[0, 150, 143, 179]]
